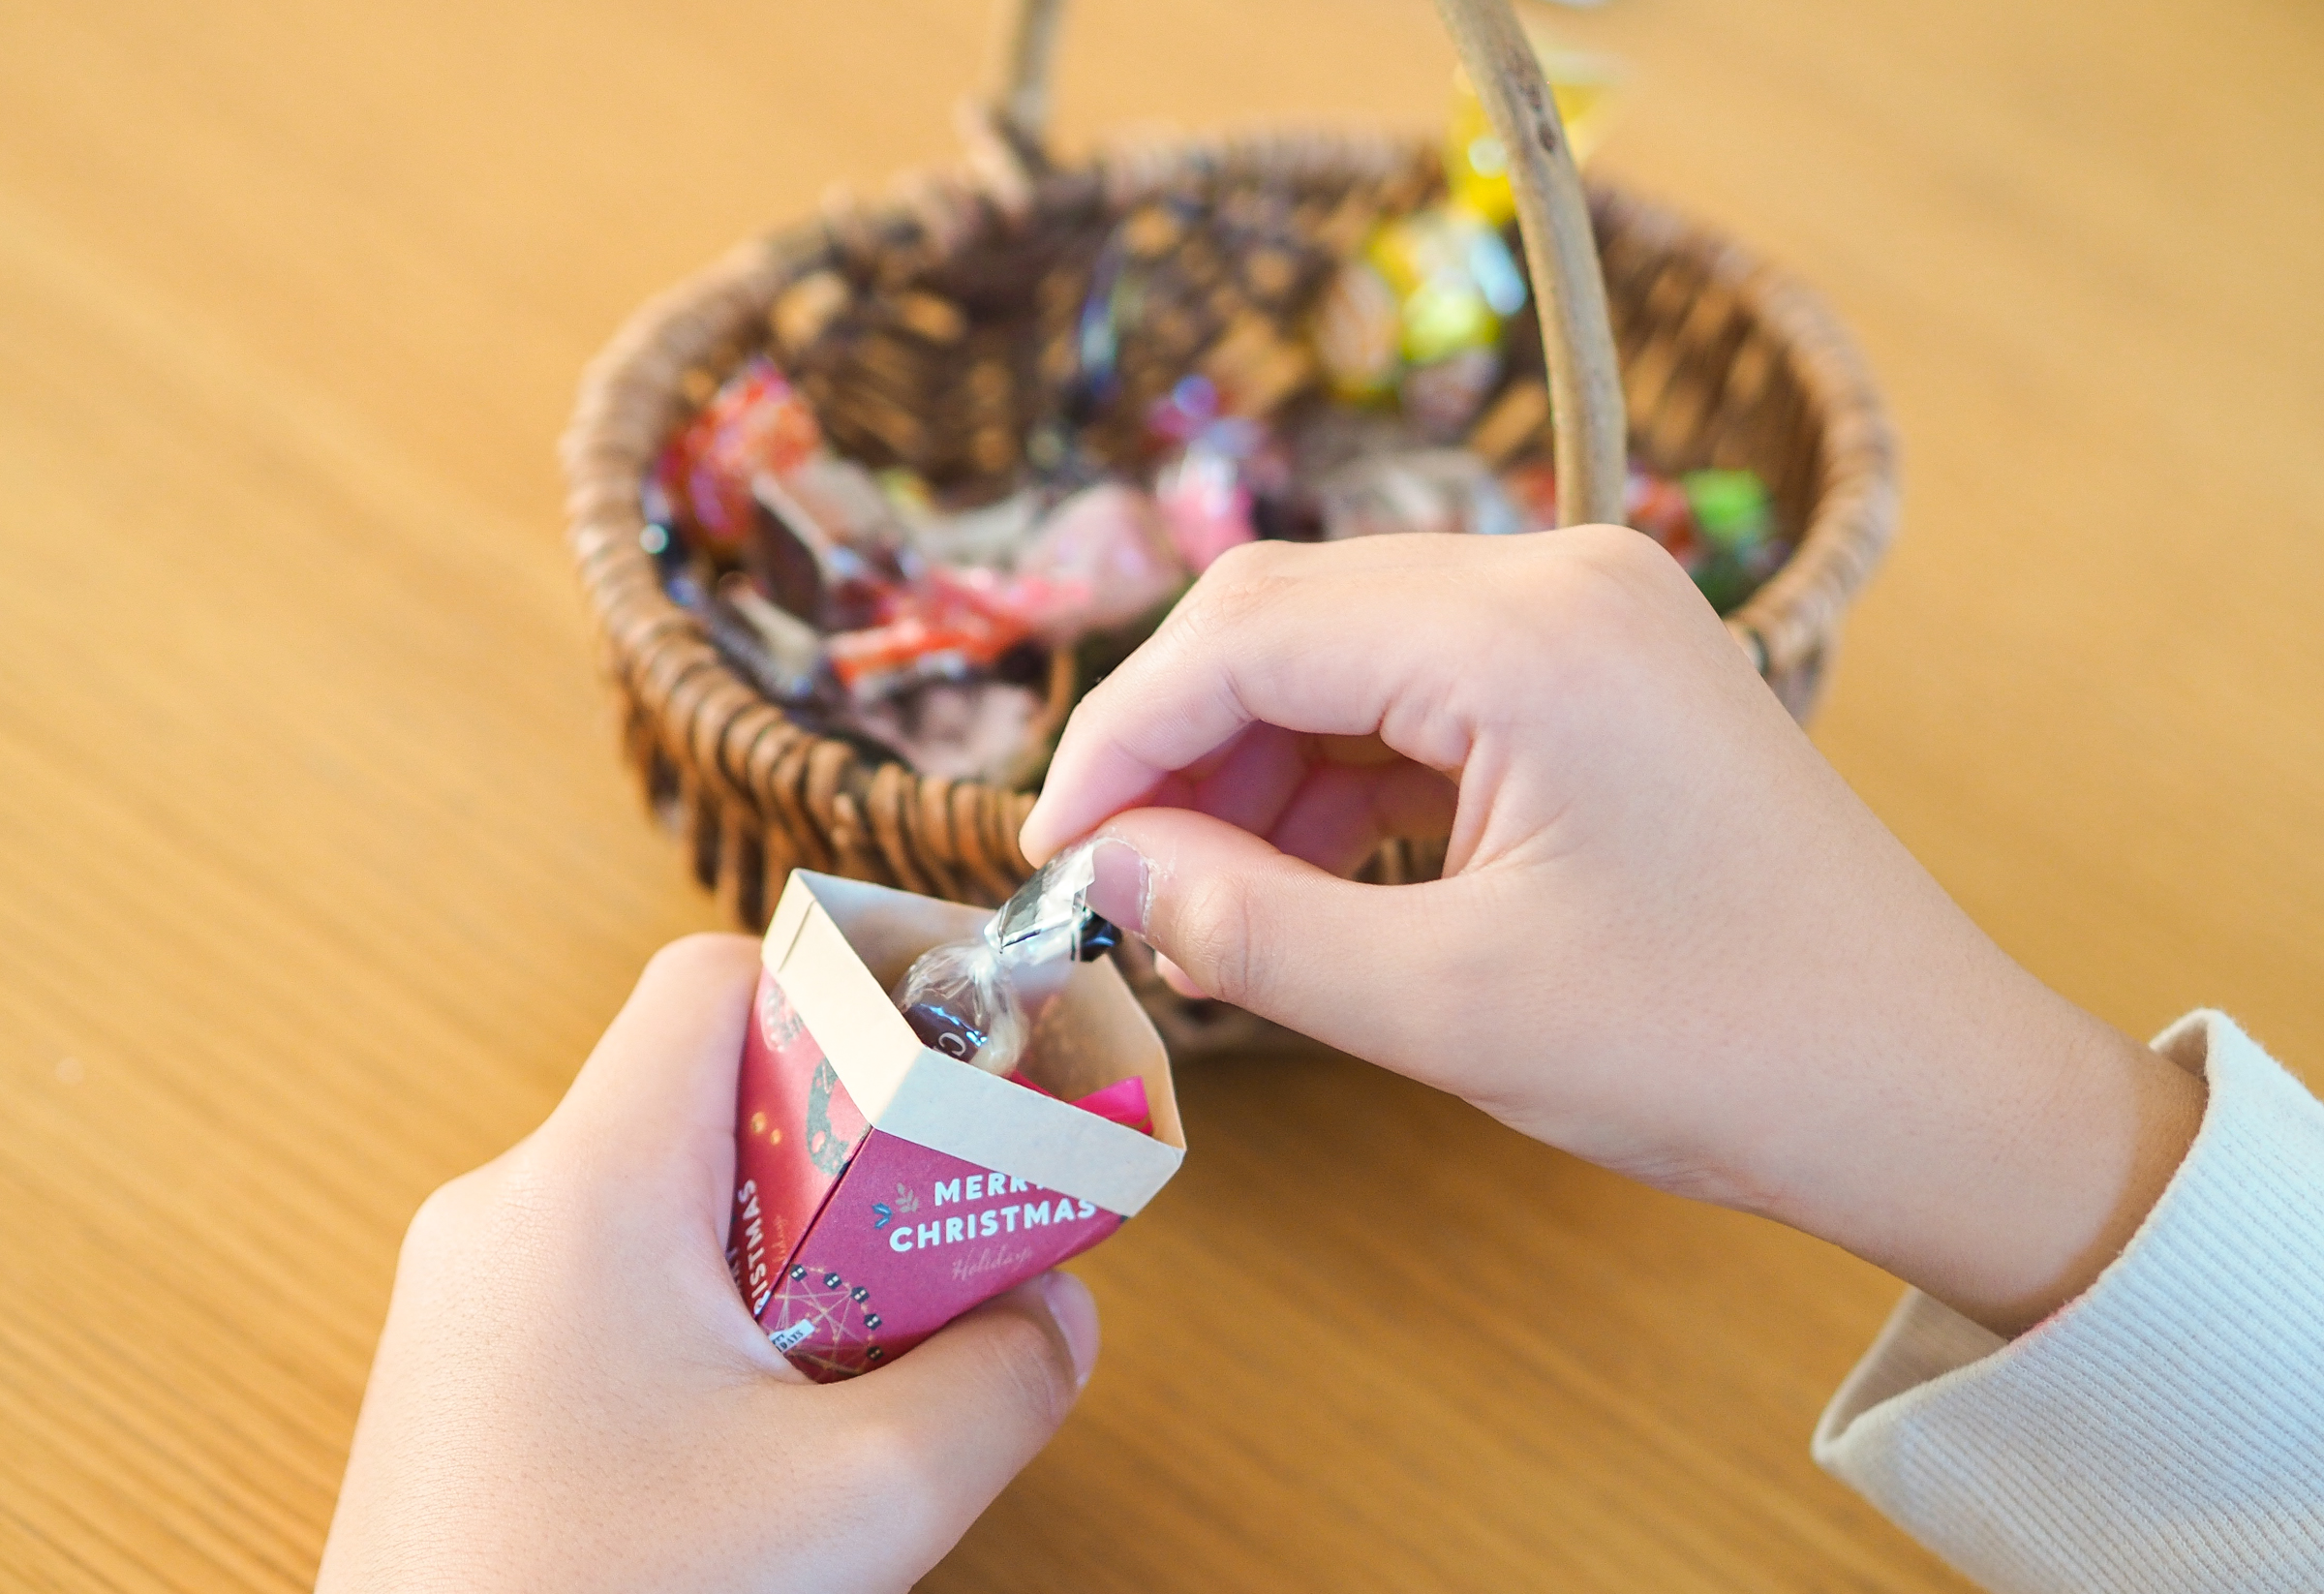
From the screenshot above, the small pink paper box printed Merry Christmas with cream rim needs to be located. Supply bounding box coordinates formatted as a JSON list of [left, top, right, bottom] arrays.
[[727, 869, 1185, 1383]]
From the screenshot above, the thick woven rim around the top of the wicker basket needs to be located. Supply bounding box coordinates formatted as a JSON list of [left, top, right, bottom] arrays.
[[560, 128, 1896, 895]]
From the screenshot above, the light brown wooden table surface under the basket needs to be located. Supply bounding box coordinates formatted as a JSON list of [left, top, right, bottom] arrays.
[[0, 0, 2324, 1592]]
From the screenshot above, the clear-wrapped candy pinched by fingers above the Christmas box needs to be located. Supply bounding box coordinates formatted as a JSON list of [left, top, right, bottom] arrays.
[[895, 843, 1120, 1076]]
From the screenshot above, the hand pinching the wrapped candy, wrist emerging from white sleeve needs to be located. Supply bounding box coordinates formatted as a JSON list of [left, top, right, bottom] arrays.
[[1024, 528, 2201, 1332]]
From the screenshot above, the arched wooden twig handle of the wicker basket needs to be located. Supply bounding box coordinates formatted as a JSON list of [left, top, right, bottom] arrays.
[[993, 0, 1627, 525]]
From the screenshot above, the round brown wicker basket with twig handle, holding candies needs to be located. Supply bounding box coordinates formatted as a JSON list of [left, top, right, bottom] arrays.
[[565, 0, 1896, 1039]]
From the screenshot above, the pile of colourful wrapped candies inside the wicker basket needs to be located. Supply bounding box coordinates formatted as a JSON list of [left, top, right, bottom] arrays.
[[644, 65, 1788, 785]]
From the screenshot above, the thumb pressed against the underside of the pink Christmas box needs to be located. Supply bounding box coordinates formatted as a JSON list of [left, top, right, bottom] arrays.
[[848, 1271, 1097, 1543]]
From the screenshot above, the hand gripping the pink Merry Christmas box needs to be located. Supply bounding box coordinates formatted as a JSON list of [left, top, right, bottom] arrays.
[[316, 936, 1097, 1594]]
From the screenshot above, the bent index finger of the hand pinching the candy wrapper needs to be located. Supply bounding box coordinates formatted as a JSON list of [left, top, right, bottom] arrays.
[[1021, 532, 1534, 862]]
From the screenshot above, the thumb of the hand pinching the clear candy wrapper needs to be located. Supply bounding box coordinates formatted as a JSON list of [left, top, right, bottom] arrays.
[[1090, 809, 1446, 1059]]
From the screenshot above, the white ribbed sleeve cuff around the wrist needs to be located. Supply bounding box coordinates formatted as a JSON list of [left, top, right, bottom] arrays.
[[1815, 1013, 2324, 1594]]
